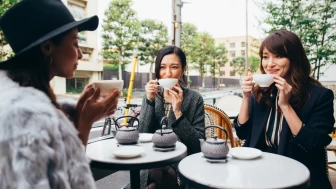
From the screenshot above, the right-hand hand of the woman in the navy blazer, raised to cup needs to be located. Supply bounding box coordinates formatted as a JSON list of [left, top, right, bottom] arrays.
[[273, 75, 292, 109]]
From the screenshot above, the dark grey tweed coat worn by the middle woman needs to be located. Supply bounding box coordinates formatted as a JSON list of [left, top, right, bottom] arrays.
[[139, 87, 205, 188]]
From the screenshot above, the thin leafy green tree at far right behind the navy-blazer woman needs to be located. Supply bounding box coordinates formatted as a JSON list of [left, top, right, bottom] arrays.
[[301, 0, 336, 80]]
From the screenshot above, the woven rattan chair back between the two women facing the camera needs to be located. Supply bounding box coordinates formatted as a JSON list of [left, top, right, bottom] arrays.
[[204, 104, 235, 148]]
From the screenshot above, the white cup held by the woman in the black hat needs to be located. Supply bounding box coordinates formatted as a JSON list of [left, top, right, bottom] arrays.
[[92, 80, 124, 95]]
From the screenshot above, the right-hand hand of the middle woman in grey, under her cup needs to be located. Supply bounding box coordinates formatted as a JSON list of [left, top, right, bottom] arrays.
[[168, 84, 183, 119]]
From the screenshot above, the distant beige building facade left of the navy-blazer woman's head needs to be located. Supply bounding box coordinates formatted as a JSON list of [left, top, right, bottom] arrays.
[[215, 36, 260, 77]]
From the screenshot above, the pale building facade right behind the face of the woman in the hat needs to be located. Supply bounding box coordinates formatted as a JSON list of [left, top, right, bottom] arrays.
[[50, 0, 103, 94]]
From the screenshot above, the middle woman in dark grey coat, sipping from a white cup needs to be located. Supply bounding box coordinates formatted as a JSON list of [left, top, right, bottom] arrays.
[[139, 46, 204, 189]]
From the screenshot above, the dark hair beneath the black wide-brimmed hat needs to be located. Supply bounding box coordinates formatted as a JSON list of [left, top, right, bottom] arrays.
[[0, 30, 71, 109]]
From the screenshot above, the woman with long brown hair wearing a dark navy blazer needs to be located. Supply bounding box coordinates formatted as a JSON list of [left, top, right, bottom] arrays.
[[234, 30, 335, 189]]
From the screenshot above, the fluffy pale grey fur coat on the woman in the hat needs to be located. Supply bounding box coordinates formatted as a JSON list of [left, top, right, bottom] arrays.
[[0, 71, 96, 189]]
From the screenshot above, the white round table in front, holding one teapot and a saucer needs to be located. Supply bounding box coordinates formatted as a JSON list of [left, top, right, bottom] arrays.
[[178, 152, 310, 189]]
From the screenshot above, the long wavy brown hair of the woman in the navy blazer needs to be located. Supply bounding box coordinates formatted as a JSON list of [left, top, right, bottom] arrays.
[[253, 30, 321, 113]]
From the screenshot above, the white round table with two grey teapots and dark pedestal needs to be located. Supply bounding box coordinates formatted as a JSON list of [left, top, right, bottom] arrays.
[[86, 139, 187, 189]]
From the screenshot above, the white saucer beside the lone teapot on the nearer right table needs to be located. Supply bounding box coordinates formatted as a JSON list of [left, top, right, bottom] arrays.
[[229, 147, 262, 159]]
